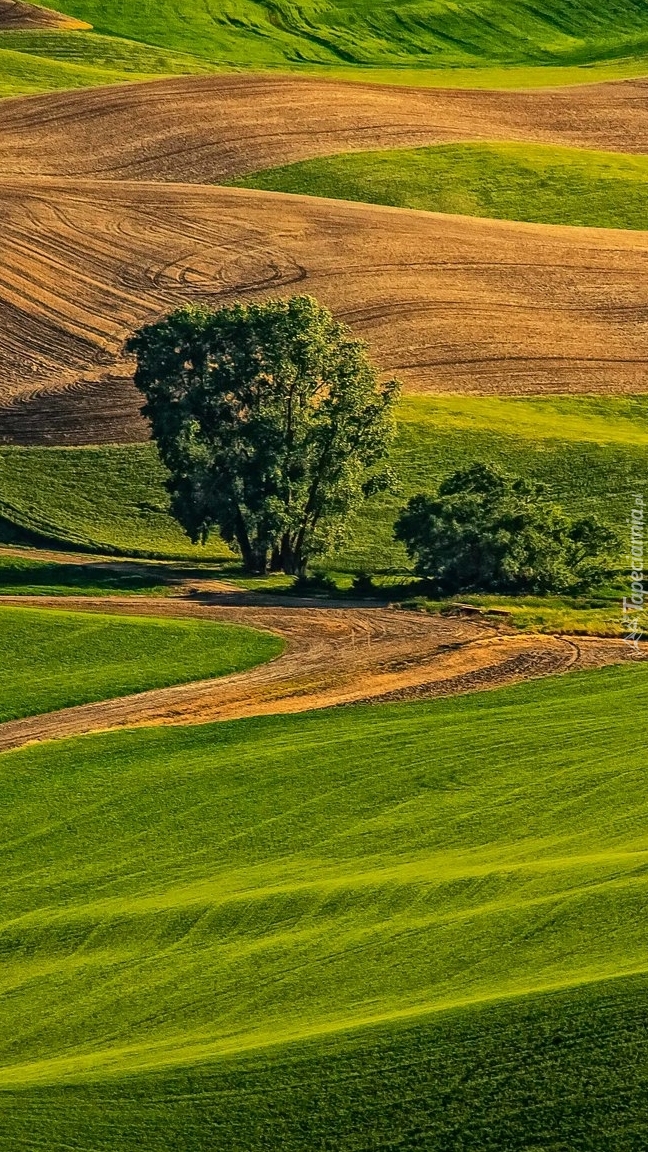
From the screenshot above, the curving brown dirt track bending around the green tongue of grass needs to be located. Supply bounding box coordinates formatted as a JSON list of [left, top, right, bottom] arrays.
[[0, 593, 633, 751]]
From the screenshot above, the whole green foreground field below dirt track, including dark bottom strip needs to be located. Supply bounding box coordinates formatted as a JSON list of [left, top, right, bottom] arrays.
[[0, 666, 648, 1152]]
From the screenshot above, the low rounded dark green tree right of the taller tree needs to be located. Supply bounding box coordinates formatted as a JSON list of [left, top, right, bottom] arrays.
[[395, 464, 617, 596]]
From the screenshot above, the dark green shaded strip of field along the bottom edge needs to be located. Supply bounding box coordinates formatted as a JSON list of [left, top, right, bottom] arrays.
[[0, 977, 648, 1152]]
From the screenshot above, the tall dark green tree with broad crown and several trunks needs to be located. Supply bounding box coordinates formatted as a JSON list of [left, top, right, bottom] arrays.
[[127, 296, 398, 574]]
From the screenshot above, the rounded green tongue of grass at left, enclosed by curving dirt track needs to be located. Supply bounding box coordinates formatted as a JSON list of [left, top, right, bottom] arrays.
[[0, 605, 277, 723]]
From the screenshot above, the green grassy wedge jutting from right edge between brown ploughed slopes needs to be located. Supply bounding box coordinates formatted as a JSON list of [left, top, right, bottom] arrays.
[[235, 144, 648, 229]]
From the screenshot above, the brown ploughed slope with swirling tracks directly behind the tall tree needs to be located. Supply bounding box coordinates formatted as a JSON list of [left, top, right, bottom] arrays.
[[0, 177, 648, 444]]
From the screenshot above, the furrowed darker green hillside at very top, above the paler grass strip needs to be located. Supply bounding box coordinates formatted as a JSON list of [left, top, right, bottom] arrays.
[[31, 0, 648, 68]]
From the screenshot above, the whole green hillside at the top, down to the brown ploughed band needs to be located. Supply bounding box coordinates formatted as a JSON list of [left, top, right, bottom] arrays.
[[0, 0, 648, 96]]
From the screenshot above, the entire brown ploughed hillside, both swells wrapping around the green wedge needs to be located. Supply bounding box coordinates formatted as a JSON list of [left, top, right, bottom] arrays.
[[0, 70, 648, 445]]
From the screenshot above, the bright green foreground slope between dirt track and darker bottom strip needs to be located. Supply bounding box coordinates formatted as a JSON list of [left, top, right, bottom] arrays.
[[0, 666, 648, 1087]]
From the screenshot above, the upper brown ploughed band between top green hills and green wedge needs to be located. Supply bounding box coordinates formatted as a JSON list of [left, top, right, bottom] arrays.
[[0, 75, 648, 184]]
